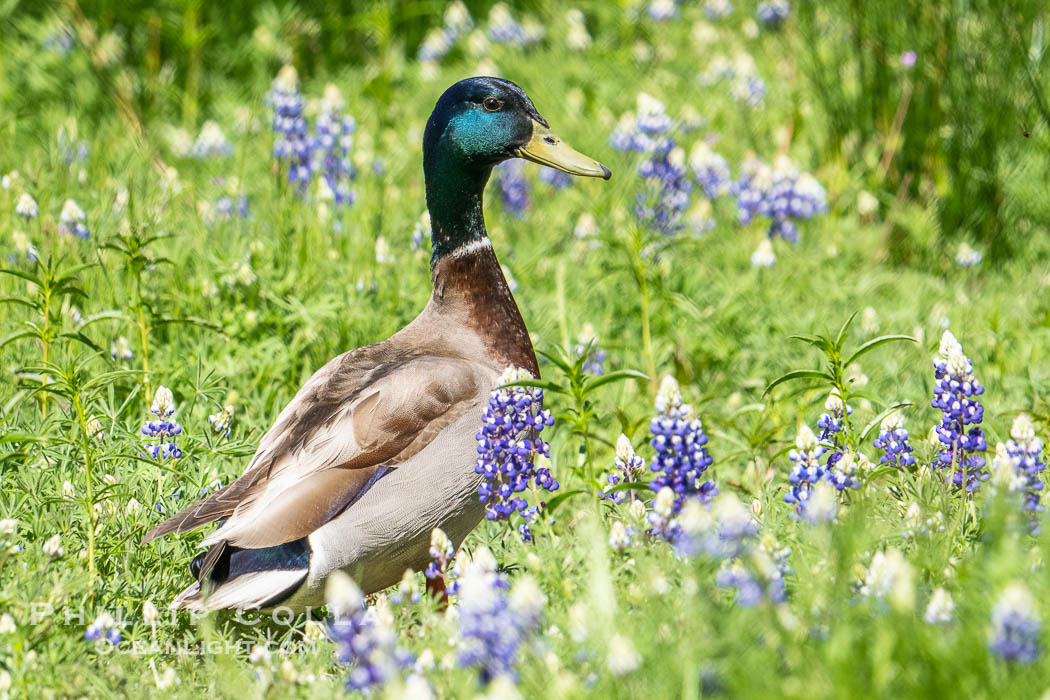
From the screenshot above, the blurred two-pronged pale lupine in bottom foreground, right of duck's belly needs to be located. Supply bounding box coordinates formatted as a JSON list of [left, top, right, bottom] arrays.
[[456, 548, 545, 683]]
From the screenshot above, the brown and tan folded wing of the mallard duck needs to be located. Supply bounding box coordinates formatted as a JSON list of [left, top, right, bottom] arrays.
[[143, 339, 491, 548]]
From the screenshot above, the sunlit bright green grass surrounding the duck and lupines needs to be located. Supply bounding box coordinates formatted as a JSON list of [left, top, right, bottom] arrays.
[[0, 3, 1050, 698]]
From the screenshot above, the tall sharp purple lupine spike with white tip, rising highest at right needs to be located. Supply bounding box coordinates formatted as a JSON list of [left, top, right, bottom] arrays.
[[930, 331, 988, 491]]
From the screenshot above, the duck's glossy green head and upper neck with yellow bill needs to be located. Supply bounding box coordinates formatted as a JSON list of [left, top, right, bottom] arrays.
[[423, 78, 612, 260]]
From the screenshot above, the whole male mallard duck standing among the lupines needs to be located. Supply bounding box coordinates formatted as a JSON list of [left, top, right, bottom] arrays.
[[144, 78, 611, 610]]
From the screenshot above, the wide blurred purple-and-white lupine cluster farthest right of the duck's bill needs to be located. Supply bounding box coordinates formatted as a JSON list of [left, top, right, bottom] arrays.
[[730, 156, 827, 243]]
